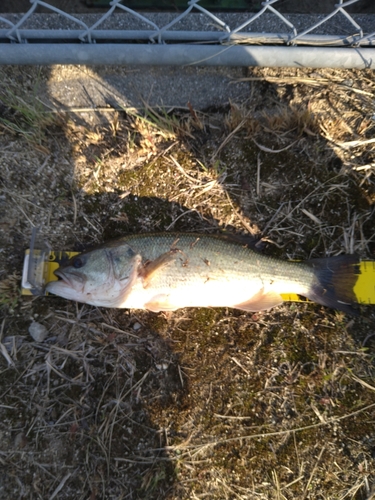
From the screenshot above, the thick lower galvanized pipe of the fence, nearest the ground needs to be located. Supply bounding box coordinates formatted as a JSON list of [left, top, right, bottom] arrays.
[[0, 43, 375, 69]]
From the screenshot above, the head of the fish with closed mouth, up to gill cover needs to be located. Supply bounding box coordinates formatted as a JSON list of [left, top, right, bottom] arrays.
[[46, 242, 142, 307]]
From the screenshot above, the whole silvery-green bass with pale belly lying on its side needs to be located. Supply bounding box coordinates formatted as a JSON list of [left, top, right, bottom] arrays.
[[46, 233, 360, 314]]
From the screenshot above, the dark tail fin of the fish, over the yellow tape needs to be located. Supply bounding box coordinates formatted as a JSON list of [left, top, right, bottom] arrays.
[[307, 255, 361, 316]]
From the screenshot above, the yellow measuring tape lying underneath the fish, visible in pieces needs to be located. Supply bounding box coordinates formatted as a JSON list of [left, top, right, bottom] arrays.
[[22, 250, 375, 304]]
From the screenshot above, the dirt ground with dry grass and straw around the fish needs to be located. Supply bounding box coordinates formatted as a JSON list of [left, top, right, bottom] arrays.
[[0, 67, 375, 500]]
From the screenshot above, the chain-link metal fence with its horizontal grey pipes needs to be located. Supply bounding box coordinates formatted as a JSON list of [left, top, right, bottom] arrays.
[[0, 0, 375, 68]]
